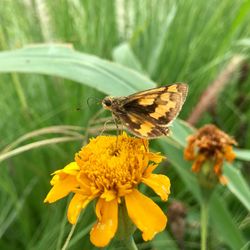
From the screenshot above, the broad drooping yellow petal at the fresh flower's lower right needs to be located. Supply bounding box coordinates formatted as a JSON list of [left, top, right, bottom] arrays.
[[125, 189, 167, 241]]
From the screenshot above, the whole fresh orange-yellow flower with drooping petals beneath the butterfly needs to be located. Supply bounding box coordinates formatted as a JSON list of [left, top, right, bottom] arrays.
[[44, 133, 170, 247]]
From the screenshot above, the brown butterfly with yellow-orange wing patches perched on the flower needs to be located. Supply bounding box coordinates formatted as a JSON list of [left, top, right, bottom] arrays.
[[102, 83, 188, 139]]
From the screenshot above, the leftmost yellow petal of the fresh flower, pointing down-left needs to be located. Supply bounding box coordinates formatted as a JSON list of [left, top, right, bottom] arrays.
[[44, 175, 78, 203]]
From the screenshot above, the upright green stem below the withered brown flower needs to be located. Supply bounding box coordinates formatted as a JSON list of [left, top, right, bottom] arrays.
[[201, 199, 208, 250]]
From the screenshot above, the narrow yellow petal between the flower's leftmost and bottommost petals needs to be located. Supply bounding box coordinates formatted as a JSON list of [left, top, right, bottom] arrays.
[[67, 194, 94, 224]]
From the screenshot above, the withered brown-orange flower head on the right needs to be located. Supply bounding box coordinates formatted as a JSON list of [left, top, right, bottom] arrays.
[[184, 124, 237, 184]]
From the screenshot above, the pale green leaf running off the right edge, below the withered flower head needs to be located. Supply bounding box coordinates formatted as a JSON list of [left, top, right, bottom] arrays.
[[224, 163, 250, 211]]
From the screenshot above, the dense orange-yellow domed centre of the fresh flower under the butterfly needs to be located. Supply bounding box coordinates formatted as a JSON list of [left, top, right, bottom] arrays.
[[75, 133, 150, 198]]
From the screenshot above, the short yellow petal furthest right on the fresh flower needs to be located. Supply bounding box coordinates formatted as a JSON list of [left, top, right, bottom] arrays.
[[142, 174, 170, 201]]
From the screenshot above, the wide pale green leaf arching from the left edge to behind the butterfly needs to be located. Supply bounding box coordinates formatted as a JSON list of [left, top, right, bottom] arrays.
[[0, 45, 156, 96]]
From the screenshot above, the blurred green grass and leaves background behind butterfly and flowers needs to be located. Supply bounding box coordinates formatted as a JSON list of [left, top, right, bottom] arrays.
[[0, 0, 250, 250]]
